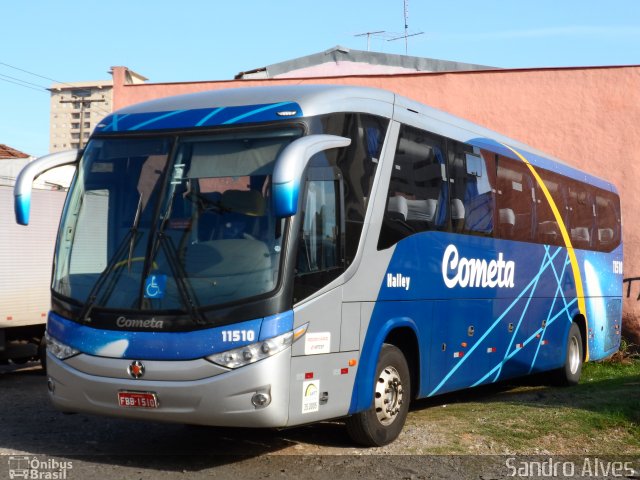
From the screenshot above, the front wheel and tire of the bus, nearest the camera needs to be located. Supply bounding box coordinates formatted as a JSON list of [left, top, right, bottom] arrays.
[[347, 343, 411, 447]]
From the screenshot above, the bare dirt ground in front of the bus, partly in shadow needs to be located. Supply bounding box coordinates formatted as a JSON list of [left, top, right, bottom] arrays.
[[0, 366, 640, 480]]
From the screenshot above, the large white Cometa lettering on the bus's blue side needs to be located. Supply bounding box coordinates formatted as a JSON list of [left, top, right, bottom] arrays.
[[442, 245, 516, 288]]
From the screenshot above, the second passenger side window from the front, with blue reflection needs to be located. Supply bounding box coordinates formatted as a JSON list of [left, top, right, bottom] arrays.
[[449, 142, 496, 236]]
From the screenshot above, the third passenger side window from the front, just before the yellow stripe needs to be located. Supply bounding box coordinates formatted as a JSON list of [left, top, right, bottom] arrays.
[[497, 156, 536, 242]]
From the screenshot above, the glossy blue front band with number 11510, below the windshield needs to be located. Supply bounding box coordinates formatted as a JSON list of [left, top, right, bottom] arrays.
[[47, 311, 293, 360]]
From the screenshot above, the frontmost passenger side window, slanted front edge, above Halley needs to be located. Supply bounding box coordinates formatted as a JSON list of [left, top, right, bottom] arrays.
[[378, 126, 448, 250]]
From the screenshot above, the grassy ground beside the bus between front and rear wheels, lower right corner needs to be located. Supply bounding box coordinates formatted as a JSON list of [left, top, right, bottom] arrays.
[[409, 360, 640, 455]]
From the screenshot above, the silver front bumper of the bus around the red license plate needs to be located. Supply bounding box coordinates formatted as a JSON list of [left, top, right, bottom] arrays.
[[47, 348, 291, 427]]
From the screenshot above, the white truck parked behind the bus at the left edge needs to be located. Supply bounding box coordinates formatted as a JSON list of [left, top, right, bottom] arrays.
[[0, 174, 66, 364]]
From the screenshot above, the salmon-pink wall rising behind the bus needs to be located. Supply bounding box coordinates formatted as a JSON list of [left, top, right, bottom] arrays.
[[113, 66, 640, 344]]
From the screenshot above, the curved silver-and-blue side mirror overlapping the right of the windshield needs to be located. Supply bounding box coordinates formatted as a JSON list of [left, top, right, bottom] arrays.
[[273, 135, 351, 218]]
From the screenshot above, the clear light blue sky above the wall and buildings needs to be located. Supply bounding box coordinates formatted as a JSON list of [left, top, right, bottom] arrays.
[[0, 0, 640, 156]]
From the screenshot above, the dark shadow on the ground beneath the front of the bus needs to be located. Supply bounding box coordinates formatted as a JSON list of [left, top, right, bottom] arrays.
[[0, 367, 353, 472]]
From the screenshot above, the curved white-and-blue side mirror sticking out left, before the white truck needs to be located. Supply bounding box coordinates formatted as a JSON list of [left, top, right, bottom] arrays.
[[13, 150, 80, 225]]
